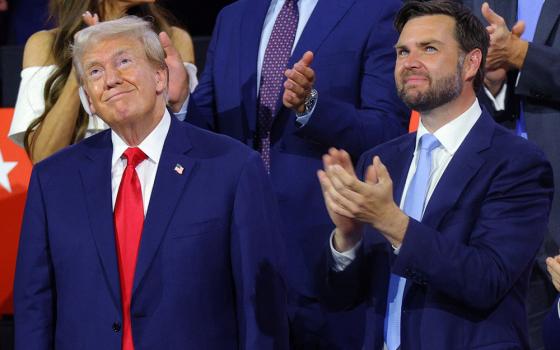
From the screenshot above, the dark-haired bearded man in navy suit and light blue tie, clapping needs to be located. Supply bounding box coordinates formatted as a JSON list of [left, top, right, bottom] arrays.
[[318, 0, 553, 350]]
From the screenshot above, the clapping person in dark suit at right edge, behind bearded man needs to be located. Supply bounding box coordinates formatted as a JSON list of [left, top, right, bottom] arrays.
[[463, 0, 560, 350]]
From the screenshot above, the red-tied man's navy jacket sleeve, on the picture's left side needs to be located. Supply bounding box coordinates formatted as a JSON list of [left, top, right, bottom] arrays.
[[14, 166, 56, 350]]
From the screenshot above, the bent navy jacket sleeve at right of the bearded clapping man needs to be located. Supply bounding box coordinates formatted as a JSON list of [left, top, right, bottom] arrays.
[[393, 148, 552, 309]]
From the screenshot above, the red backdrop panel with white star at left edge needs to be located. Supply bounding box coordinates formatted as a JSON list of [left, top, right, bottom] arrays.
[[0, 108, 31, 315]]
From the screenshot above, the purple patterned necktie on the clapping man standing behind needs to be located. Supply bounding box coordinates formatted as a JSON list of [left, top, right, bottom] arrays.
[[257, 0, 299, 173]]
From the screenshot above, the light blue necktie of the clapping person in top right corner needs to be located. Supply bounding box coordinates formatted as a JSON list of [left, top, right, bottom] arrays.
[[515, 0, 544, 138]]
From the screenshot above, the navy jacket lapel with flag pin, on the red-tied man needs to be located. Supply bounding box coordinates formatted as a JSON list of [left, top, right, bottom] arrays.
[[132, 116, 197, 295]]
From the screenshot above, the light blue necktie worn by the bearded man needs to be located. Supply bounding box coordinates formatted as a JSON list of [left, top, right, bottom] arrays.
[[384, 134, 440, 350]]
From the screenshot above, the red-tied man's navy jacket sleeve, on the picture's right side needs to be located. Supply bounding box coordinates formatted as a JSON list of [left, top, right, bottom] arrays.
[[231, 152, 288, 349]]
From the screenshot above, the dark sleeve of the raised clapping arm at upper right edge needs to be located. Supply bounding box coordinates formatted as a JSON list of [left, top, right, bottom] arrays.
[[515, 43, 560, 102]]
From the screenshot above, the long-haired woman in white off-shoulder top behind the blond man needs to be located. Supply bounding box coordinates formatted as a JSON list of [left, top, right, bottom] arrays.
[[9, 0, 197, 163]]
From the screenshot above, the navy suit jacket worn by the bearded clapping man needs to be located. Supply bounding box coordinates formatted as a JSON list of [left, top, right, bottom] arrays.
[[324, 108, 553, 350]]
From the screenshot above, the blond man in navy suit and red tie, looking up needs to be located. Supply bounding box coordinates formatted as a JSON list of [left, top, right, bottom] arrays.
[[14, 16, 288, 350]]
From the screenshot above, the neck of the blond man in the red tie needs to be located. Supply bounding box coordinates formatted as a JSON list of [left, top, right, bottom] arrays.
[[111, 100, 165, 147]]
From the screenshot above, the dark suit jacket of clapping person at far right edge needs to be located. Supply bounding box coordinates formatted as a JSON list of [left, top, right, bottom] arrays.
[[463, 0, 560, 273]]
